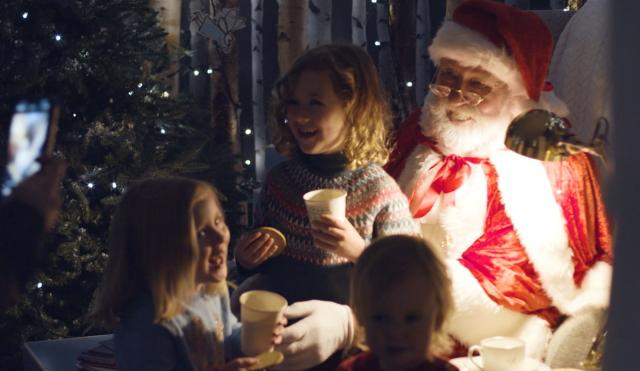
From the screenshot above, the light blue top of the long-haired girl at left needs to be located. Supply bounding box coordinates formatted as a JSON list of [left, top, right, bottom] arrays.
[[114, 293, 241, 371]]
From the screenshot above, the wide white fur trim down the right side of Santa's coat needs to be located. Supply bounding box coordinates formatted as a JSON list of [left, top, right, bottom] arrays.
[[491, 151, 611, 315]]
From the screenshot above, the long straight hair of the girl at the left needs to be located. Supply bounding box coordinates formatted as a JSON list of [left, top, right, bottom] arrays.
[[91, 177, 218, 327]]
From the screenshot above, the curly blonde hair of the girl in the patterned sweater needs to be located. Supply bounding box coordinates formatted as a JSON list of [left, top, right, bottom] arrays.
[[271, 44, 391, 169]]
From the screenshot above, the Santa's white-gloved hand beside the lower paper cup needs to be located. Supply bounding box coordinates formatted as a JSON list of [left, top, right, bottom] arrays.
[[275, 300, 354, 370]]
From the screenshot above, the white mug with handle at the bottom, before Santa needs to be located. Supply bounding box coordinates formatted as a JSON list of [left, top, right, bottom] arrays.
[[467, 336, 526, 371]]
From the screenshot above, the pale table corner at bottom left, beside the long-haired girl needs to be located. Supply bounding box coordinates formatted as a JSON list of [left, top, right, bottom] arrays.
[[22, 334, 113, 371]]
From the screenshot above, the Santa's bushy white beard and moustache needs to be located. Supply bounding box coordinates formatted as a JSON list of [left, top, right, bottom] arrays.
[[420, 92, 514, 157]]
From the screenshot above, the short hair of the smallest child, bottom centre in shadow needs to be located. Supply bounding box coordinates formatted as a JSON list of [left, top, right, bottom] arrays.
[[351, 235, 453, 356]]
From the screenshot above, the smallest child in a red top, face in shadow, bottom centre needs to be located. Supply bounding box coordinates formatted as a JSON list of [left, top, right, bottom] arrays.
[[338, 236, 457, 371]]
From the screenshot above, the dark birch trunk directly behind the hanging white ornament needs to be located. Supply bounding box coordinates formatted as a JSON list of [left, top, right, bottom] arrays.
[[209, 0, 240, 154]]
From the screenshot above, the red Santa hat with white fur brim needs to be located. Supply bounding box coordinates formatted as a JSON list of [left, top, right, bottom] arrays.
[[429, 0, 568, 116]]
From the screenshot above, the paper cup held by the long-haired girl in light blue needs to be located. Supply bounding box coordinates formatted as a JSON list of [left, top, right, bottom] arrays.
[[240, 290, 287, 356]]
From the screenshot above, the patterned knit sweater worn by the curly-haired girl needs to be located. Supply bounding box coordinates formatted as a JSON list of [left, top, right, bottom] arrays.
[[242, 155, 418, 303]]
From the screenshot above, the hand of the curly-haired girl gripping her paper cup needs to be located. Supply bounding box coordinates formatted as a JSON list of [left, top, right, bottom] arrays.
[[311, 215, 365, 262]]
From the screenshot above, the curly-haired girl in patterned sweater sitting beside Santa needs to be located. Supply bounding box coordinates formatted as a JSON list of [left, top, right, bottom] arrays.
[[233, 45, 417, 310]]
